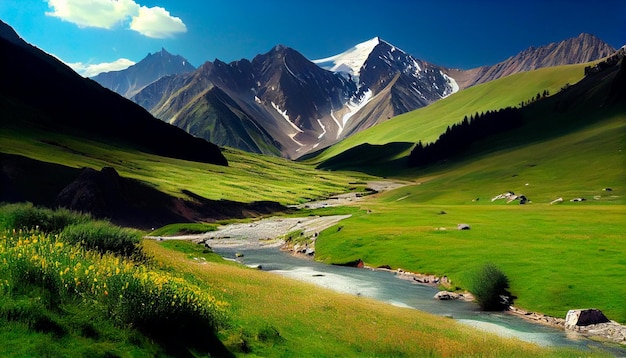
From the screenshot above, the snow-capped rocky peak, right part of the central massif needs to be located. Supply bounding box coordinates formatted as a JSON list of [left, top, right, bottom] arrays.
[[313, 37, 459, 138]]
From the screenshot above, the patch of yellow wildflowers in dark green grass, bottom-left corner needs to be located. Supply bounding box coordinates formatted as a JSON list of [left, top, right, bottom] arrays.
[[0, 206, 228, 356]]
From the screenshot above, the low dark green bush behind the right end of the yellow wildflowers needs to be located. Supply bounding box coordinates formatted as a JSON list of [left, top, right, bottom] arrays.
[[60, 221, 142, 257]]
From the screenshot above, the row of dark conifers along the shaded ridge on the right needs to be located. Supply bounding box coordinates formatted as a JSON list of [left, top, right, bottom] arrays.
[[408, 107, 522, 167]]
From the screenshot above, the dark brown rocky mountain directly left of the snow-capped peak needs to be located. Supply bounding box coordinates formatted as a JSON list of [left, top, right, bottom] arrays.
[[133, 45, 356, 157]]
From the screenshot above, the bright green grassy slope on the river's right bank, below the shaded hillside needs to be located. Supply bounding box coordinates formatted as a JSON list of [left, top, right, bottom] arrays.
[[316, 113, 626, 323]]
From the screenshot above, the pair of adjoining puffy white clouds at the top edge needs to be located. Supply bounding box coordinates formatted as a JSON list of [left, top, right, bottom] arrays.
[[46, 0, 187, 38]]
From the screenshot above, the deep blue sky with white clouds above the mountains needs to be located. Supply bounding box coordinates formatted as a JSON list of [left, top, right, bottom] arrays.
[[0, 0, 626, 73]]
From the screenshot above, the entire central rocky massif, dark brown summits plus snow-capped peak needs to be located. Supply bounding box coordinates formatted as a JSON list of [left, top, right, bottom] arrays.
[[132, 38, 458, 158]]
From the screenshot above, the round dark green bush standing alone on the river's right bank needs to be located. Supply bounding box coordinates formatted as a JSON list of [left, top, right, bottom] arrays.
[[469, 264, 511, 311]]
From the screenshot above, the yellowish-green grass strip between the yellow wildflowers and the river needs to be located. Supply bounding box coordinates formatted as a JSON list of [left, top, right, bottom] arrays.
[[144, 241, 580, 357]]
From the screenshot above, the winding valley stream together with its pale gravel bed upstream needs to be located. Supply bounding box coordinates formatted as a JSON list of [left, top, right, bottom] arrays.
[[167, 182, 626, 357]]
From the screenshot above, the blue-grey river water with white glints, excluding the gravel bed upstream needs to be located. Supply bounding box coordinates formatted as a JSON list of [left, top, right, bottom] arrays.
[[212, 241, 626, 357]]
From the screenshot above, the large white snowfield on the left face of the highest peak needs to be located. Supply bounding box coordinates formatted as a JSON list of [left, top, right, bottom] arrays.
[[312, 37, 382, 76]]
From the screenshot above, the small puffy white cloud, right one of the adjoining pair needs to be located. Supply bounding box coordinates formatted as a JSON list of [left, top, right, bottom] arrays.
[[130, 6, 187, 39]]
